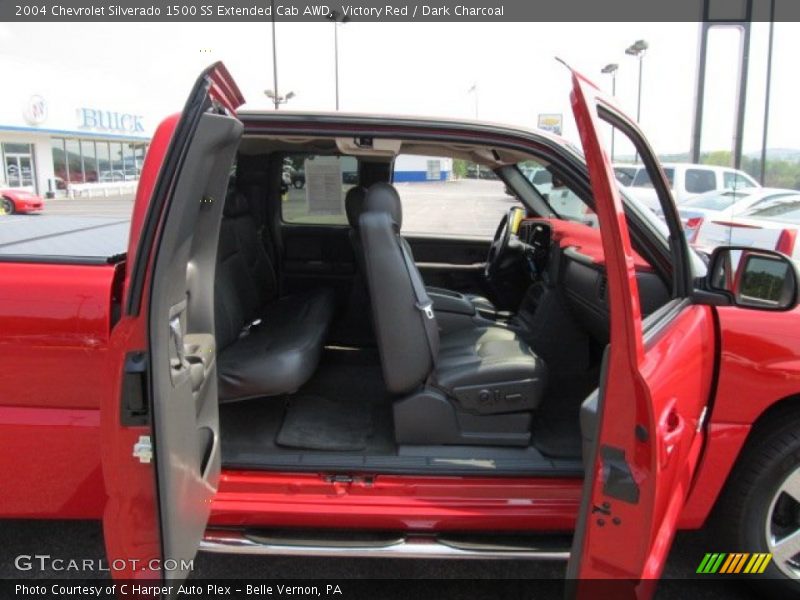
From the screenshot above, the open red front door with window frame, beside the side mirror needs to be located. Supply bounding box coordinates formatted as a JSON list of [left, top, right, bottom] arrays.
[[568, 72, 717, 598]]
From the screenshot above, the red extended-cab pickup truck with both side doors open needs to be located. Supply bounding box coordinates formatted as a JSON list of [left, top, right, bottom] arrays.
[[0, 64, 800, 597]]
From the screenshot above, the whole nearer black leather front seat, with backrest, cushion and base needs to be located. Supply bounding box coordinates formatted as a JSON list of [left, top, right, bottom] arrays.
[[359, 183, 547, 445]]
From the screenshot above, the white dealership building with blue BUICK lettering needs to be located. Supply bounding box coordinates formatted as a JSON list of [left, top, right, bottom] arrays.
[[0, 79, 158, 196]]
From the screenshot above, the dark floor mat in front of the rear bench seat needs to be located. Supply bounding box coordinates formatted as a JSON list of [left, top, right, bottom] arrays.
[[275, 394, 373, 451]]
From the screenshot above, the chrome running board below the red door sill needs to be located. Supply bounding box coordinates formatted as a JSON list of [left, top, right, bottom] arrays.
[[200, 528, 569, 560]]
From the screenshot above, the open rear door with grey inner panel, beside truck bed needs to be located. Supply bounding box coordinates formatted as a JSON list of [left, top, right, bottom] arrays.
[[101, 63, 243, 579]]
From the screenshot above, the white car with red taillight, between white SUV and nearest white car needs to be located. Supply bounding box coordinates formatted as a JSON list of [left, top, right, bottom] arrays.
[[680, 188, 797, 246]]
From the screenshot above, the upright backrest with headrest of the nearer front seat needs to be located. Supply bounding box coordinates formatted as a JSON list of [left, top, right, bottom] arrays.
[[358, 183, 439, 394]]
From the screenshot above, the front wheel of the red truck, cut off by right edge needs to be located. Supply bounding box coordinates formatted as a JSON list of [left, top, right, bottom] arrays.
[[709, 410, 800, 597]]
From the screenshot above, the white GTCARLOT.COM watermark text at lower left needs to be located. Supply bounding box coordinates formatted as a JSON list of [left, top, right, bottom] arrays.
[[14, 554, 194, 573]]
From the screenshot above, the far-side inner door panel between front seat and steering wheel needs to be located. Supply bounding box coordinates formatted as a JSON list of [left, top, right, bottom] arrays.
[[405, 236, 491, 293]]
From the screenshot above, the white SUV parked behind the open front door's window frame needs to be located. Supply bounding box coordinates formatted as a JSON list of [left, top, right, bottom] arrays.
[[629, 163, 761, 212]]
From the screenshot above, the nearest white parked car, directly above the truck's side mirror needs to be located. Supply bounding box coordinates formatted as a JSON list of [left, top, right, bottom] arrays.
[[694, 192, 800, 260]]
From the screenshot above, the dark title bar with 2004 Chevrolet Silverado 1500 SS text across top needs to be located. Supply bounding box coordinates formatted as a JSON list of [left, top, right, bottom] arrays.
[[0, 0, 800, 22]]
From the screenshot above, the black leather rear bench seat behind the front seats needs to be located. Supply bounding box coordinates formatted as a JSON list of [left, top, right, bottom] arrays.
[[215, 191, 334, 402]]
